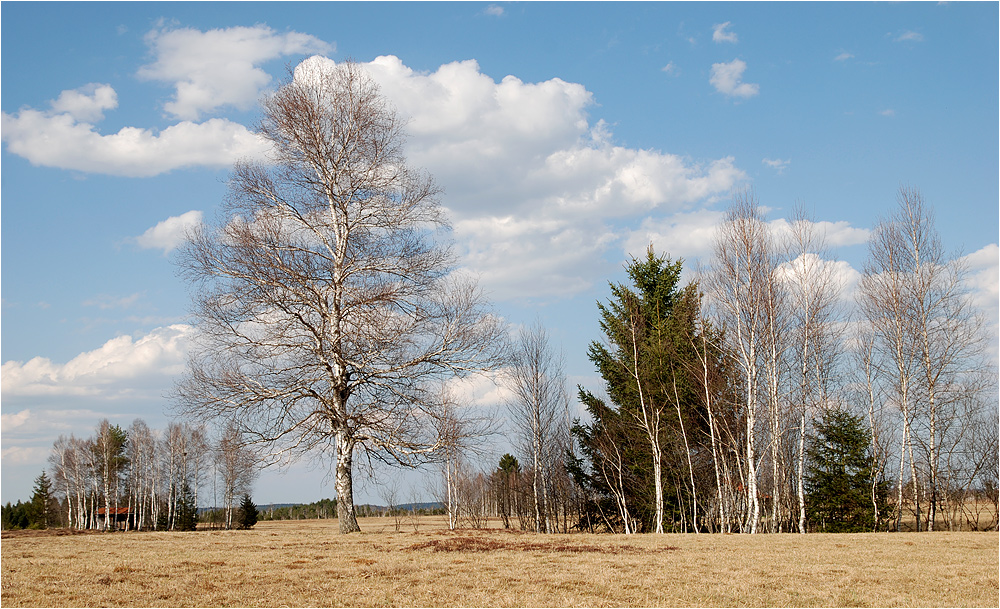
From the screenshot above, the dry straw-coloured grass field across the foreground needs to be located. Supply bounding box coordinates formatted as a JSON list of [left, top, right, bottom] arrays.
[[0, 519, 1000, 607]]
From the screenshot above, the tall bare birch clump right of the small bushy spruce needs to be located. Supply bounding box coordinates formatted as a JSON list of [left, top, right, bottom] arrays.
[[859, 187, 995, 530]]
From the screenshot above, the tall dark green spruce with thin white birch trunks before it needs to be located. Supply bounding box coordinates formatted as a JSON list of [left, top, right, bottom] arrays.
[[567, 248, 722, 531]]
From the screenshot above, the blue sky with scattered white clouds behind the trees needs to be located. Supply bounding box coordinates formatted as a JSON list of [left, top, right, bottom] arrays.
[[0, 2, 1000, 504]]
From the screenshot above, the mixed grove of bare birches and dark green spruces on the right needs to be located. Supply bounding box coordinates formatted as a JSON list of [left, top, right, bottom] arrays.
[[446, 188, 998, 533]]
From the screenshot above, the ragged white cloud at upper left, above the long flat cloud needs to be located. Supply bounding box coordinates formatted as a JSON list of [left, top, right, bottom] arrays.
[[138, 25, 332, 120]]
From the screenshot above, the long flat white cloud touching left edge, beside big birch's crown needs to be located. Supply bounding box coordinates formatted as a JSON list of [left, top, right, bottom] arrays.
[[0, 106, 267, 177]]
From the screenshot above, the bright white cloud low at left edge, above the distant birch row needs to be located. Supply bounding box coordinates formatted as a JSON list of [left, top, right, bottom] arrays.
[[0, 324, 194, 399]]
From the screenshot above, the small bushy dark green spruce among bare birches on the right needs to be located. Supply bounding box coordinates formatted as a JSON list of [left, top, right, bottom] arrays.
[[806, 410, 888, 533]]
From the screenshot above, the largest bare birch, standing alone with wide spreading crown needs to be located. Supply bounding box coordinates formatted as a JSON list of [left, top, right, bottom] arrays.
[[176, 59, 505, 533]]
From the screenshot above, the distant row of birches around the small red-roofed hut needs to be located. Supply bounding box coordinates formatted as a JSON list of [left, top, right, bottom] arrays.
[[5, 419, 259, 530]]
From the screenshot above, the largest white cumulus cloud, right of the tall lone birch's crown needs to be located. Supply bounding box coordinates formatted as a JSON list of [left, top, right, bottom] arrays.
[[288, 56, 746, 299]]
